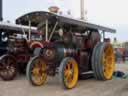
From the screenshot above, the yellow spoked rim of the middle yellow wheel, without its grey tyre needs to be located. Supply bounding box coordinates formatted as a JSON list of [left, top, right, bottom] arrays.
[[64, 60, 78, 88]]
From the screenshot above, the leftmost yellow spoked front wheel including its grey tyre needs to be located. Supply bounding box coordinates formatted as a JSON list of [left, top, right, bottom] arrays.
[[26, 56, 47, 86]]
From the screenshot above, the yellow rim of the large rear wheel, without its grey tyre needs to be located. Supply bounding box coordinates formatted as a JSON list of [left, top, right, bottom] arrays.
[[102, 44, 114, 79]]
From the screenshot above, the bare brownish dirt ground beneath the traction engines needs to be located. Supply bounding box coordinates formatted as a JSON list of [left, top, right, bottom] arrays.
[[0, 64, 128, 96]]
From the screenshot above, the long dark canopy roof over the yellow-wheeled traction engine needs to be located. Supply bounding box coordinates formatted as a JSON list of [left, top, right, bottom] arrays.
[[16, 11, 116, 33]]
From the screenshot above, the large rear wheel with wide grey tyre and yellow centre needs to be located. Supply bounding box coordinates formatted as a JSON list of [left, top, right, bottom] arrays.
[[92, 42, 115, 80]]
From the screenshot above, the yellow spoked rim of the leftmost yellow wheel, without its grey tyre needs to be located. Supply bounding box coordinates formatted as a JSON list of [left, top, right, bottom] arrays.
[[31, 58, 47, 85]]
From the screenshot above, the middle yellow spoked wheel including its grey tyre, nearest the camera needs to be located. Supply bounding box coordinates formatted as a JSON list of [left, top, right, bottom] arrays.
[[59, 57, 78, 89]]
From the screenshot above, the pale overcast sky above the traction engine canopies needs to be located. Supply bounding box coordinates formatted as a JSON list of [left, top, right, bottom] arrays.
[[3, 0, 128, 41]]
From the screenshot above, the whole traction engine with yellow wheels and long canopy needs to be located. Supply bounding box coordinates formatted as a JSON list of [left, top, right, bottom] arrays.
[[16, 11, 115, 89]]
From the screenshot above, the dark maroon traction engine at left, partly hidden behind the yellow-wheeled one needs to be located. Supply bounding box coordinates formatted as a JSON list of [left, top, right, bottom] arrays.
[[0, 22, 43, 80]]
